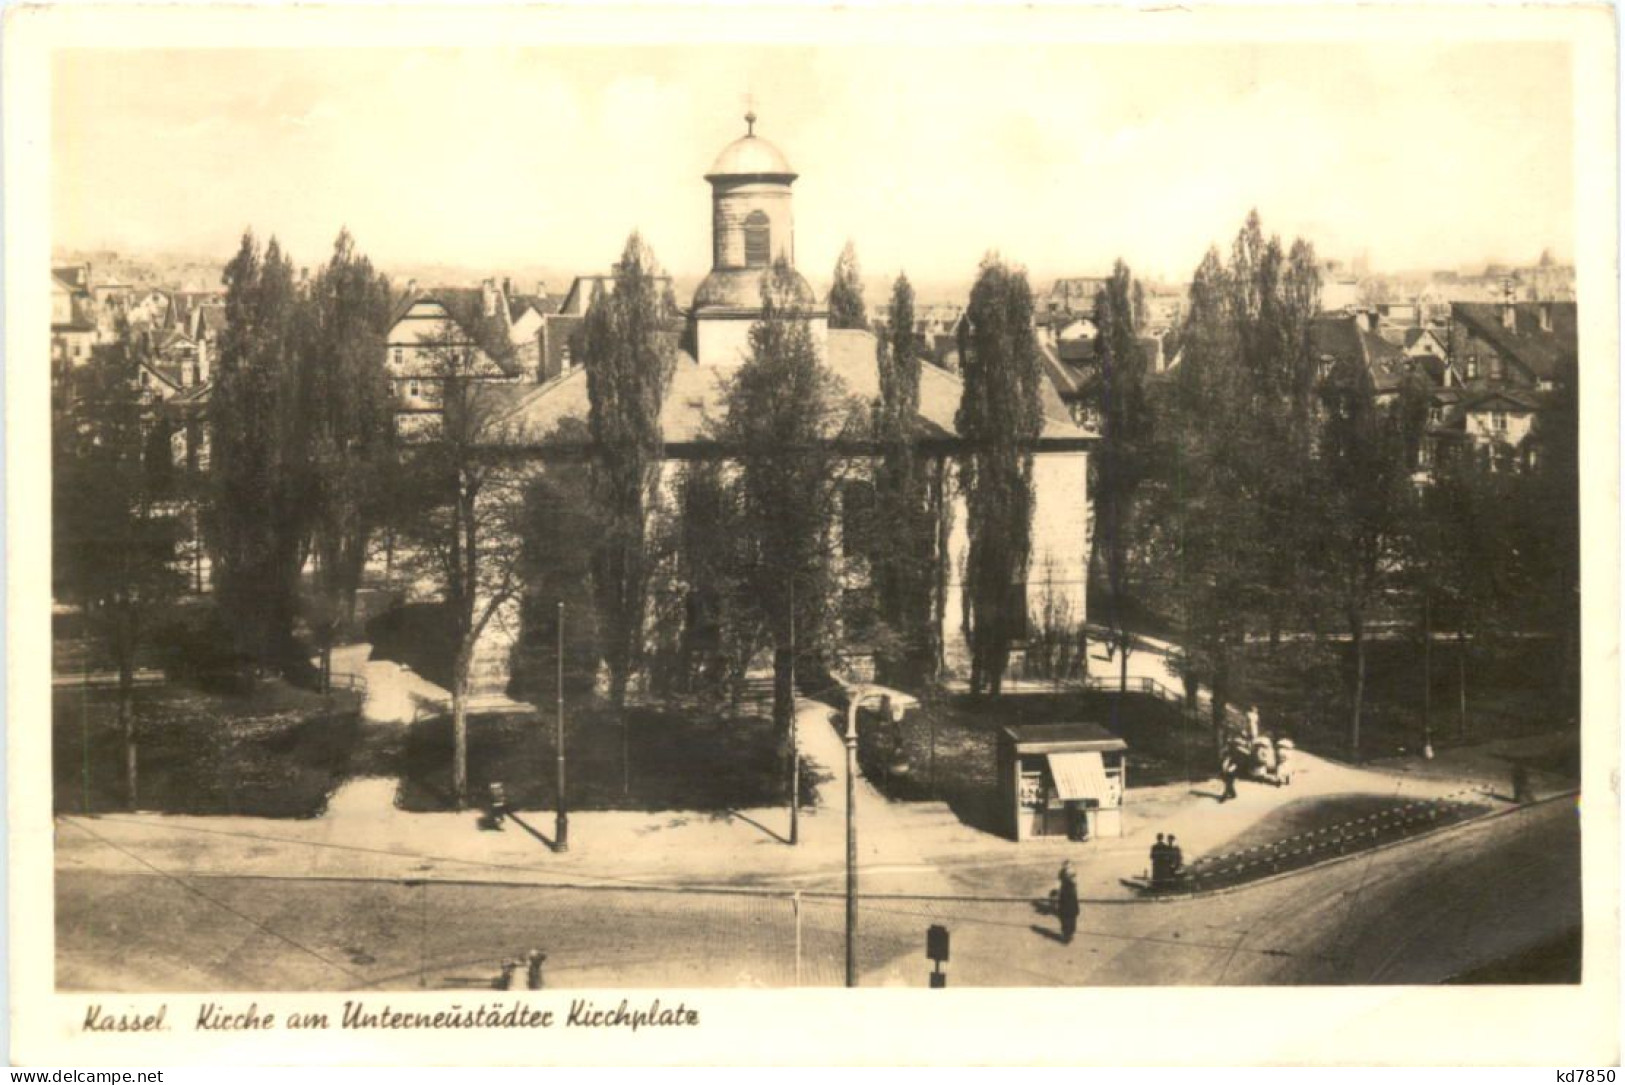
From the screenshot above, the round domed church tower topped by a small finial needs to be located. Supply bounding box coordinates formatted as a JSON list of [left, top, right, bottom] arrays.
[[691, 112, 829, 365]]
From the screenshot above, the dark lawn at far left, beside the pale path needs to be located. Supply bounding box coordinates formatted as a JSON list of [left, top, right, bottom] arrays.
[[52, 682, 359, 817]]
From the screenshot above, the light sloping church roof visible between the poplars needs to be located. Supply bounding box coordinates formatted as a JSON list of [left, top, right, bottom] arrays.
[[486, 328, 1094, 445]]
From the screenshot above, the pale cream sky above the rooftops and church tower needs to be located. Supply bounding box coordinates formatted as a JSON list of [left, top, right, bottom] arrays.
[[52, 41, 1575, 283]]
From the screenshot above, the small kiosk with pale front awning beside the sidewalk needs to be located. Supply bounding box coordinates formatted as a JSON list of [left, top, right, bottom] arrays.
[[999, 723, 1128, 840]]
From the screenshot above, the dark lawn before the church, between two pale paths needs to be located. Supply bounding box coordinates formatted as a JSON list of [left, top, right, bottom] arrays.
[[397, 702, 832, 812]]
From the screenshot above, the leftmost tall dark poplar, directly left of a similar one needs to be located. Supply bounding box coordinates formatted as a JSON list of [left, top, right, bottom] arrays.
[[205, 232, 312, 668]]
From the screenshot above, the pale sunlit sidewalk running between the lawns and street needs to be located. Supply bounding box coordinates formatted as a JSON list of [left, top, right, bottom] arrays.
[[47, 645, 1534, 900]]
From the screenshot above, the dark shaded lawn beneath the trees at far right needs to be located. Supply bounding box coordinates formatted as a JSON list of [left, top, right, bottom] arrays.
[[1232, 640, 1570, 757]]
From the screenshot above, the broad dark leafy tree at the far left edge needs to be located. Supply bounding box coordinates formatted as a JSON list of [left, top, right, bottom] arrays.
[[52, 328, 185, 809]]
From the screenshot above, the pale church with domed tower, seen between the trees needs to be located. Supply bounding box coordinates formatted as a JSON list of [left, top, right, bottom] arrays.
[[476, 114, 1097, 689]]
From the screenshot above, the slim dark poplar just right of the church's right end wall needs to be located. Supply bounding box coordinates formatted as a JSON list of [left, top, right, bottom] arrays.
[[1094, 260, 1152, 711]]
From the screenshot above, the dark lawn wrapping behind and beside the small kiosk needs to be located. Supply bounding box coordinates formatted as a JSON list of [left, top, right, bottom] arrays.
[[858, 690, 1212, 832]]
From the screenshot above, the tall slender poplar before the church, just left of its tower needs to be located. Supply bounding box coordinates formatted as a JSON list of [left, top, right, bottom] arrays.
[[583, 234, 676, 789]]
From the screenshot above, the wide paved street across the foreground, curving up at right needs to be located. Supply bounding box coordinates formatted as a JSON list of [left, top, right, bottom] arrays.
[[57, 801, 1580, 991]]
